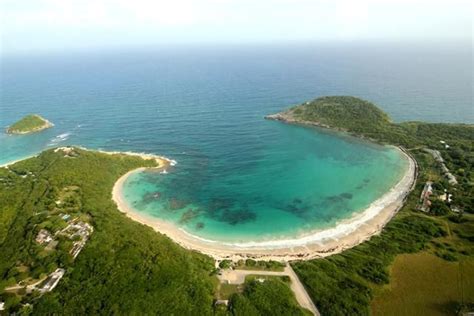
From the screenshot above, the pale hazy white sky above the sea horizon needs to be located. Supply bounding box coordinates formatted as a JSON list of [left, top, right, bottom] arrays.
[[0, 0, 473, 54]]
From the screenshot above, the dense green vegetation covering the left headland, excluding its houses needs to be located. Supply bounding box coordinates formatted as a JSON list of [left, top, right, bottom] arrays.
[[0, 149, 213, 315]]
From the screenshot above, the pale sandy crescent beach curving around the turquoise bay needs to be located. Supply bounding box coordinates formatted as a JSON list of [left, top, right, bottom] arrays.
[[112, 147, 417, 261]]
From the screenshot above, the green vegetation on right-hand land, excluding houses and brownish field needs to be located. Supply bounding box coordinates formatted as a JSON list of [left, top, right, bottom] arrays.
[[282, 97, 474, 315]]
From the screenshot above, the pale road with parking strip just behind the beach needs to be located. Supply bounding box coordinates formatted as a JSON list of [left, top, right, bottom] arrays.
[[219, 265, 320, 316]]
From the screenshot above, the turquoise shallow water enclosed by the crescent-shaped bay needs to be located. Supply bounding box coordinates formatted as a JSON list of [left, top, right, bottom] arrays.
[[119, 124, 408, 242]]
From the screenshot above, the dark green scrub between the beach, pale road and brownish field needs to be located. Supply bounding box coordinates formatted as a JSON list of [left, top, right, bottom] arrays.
[[293, 215, 445, 315]]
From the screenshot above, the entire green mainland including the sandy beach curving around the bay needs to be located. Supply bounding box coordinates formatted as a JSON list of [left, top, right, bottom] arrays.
[[0, 97, 474, 315]]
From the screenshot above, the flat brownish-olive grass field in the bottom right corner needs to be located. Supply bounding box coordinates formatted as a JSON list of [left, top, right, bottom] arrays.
[[372, 253, 474, 316]]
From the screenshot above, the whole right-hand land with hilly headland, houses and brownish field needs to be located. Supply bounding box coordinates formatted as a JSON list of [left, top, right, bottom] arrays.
[[266, 96, 474, 315]]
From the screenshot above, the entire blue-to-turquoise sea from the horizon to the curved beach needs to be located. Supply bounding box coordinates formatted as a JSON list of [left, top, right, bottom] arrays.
[[0, 44, 474, 240]]
